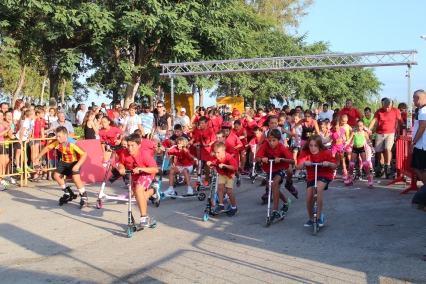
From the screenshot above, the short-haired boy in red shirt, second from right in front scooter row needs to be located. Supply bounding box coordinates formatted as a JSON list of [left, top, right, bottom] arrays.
[[256, 129, 298, 219]]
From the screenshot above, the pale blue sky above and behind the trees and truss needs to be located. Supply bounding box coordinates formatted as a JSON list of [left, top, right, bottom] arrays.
[[88, 0, 426, 108]]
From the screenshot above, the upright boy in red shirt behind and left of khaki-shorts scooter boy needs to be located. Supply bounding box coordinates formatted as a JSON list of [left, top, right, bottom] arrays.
[[191, 116, 216, 186]]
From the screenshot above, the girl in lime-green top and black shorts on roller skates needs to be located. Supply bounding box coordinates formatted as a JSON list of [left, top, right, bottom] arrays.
[[345, 119, 373, 187]]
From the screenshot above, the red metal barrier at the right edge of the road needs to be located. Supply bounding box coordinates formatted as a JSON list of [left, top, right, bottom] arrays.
[[387, 136, 419, 194]]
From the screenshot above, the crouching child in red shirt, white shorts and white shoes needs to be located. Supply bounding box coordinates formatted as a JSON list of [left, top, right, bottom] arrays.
[[164, 137, 198, 195]]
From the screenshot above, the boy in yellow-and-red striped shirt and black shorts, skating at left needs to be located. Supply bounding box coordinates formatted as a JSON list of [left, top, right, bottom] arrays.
[[34, 126, 88, 209]]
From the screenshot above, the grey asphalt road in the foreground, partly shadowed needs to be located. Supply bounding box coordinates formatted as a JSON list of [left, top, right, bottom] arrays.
[[0, 173, 426, 283]]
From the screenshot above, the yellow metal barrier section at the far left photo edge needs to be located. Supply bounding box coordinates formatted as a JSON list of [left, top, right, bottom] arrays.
[[0, 140, 24, 186]]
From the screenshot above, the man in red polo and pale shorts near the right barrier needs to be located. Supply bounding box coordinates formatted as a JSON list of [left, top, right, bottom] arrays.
[[368, 99, 404, 178]]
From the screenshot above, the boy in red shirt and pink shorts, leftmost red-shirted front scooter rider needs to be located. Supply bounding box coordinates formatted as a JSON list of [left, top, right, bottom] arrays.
[[118, 133, 160, 227]]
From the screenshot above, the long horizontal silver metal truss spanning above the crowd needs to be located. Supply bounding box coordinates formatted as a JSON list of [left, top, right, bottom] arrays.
[[160, 50, 417, 76]]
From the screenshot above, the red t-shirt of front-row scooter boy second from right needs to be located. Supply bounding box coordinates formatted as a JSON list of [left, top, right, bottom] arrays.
[[256, 142, 293, 173]]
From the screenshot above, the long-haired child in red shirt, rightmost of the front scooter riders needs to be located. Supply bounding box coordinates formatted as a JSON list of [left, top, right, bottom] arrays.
[[296, 135, 337, 227]]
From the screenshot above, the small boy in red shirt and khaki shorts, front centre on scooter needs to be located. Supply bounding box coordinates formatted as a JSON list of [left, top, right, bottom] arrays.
[[207, 142, 238, 217]]
